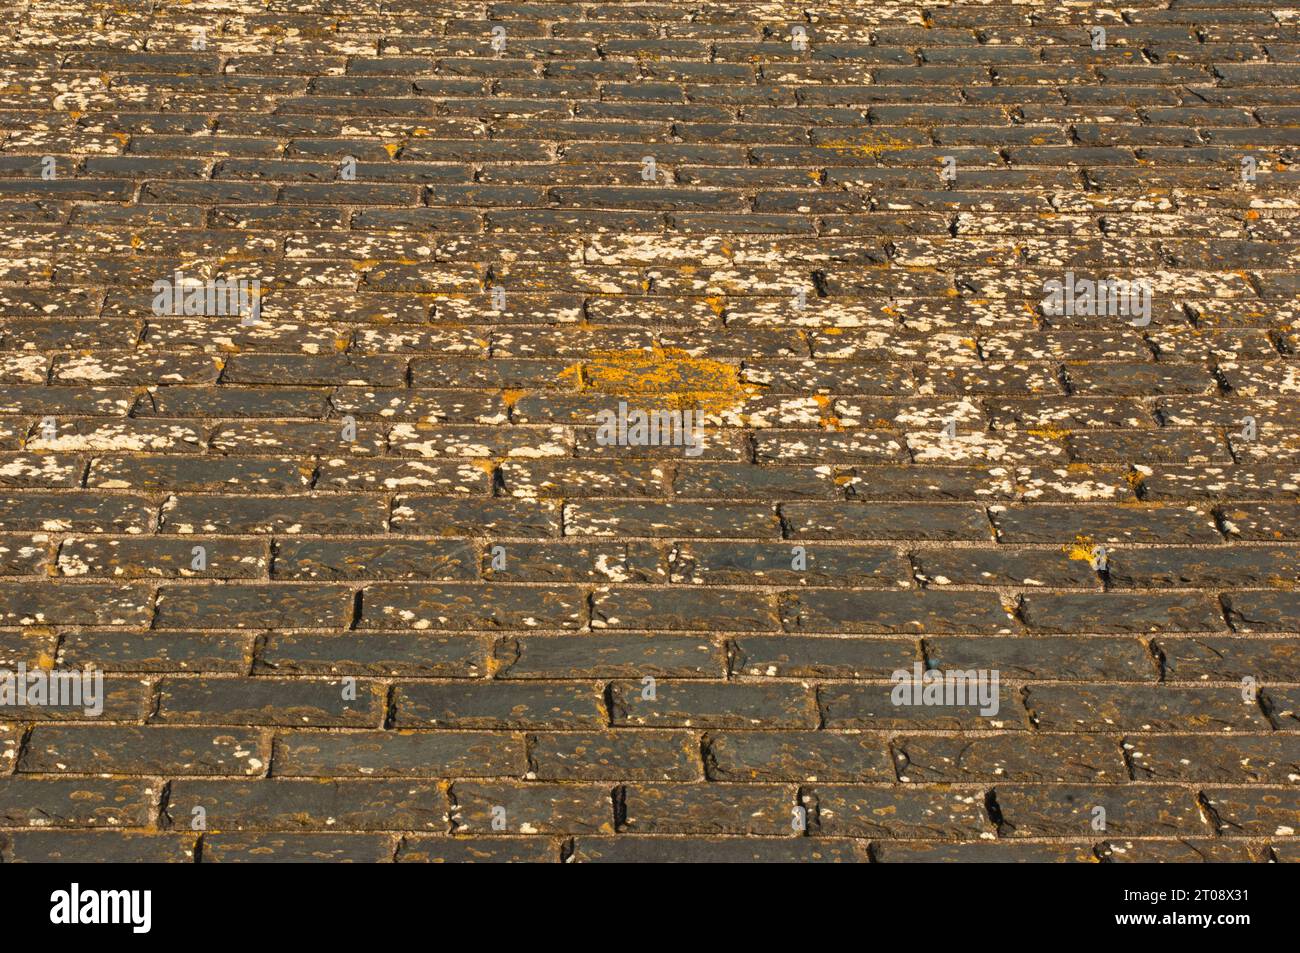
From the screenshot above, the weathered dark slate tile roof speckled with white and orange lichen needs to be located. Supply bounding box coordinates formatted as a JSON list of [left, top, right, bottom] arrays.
[[0, 0, 1300, 862]]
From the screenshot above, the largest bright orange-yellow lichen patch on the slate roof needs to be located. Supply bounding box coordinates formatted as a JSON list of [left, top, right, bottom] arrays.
[[560, 345, 758, 412]]
